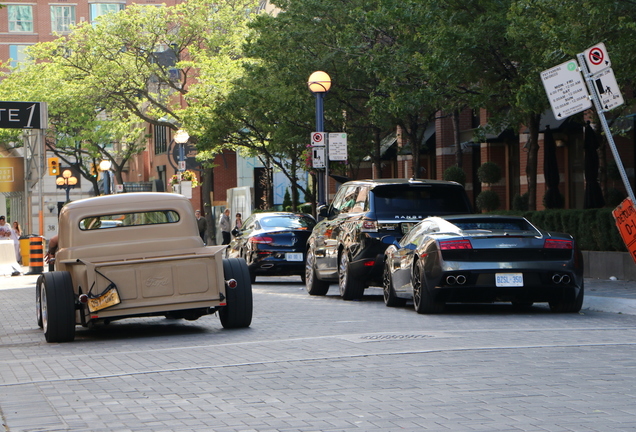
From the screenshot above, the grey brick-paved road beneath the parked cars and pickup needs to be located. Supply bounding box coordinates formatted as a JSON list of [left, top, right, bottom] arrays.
[[0, 278, 636, 432]]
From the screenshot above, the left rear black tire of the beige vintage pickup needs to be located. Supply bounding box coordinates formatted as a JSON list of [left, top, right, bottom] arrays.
[[36, 271, 75, 342]]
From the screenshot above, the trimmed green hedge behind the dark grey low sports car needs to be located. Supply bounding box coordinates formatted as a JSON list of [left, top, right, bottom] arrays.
[[490, 208, 627, 252]]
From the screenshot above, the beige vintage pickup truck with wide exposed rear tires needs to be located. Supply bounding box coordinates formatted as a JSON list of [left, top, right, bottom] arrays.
[[36, 192, 252, 342]]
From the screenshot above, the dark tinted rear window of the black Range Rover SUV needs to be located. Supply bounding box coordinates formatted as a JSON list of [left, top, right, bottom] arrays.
[[373, 185, 471, 219]]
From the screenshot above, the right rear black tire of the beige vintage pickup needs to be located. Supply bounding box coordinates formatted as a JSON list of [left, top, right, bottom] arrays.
[[219, 258, 252, 329]]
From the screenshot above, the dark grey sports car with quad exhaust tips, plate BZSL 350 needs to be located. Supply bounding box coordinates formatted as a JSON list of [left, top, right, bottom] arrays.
[[383, 215, 584, 313]]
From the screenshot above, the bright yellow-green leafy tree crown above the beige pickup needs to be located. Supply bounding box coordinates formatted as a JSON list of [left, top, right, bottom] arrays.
[[8, 0, 256, 194]]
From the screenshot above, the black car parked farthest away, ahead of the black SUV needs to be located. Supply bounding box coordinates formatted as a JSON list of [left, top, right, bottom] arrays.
[[228, 212, 316, 282]]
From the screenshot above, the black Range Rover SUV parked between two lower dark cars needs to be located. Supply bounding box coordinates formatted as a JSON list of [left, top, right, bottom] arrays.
[[305, 179, 472, 300]]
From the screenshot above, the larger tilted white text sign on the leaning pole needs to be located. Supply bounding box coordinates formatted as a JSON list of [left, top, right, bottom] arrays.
[[541, 60, 592, 119]]
